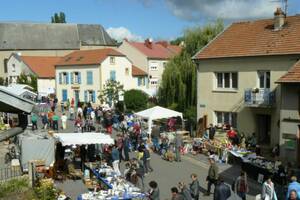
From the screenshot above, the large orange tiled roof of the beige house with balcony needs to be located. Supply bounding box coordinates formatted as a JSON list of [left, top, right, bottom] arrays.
[[194, 15, 300, 59]]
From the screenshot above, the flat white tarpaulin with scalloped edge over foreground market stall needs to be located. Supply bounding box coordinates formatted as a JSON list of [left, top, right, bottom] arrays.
[[54, 133, 114, 146]]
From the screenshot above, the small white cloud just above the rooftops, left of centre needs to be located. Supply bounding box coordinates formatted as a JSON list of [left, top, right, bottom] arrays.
[[106, 26, 143, 42]]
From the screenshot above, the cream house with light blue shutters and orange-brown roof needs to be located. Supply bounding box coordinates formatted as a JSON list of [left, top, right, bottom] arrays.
[[55, 48, 147, 105]]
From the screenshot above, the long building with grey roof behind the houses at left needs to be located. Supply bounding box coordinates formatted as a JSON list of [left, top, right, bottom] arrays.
[[0, 23, 115, 81]]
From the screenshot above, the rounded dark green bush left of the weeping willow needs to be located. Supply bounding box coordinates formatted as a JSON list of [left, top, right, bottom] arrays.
[[124, 89, 149, 111]]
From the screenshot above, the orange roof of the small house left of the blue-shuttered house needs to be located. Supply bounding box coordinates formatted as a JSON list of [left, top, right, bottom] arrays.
[[20, 56, 62, 78]]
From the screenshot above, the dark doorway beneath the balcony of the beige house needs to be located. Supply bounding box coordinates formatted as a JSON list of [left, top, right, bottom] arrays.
[[256, 114, 271, 145]]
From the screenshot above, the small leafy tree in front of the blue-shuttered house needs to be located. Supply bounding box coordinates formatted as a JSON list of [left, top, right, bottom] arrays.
[[98, 80, 124, 105]]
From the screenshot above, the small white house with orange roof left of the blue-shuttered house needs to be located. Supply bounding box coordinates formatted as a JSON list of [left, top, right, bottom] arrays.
[[7, 53, 61, 96]]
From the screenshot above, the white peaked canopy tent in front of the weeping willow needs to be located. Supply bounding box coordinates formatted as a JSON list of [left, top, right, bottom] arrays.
[[135, 106, 183, 134]]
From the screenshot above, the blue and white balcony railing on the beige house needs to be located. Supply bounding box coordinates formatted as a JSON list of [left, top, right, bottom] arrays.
[[244, 88, 275, 107]]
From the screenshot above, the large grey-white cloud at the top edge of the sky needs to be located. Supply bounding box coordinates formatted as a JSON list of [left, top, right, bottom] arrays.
[[165, 0, 281, 21]]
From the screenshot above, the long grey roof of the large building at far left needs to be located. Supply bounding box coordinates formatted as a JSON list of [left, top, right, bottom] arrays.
[[0, 23, 115, 50]]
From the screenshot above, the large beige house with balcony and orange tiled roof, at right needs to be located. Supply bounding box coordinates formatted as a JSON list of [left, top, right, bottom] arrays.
[[194, 10, 300, 162]]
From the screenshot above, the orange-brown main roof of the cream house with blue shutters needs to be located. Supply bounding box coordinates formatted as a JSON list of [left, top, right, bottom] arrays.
[[56, 48, 125, 66]]
